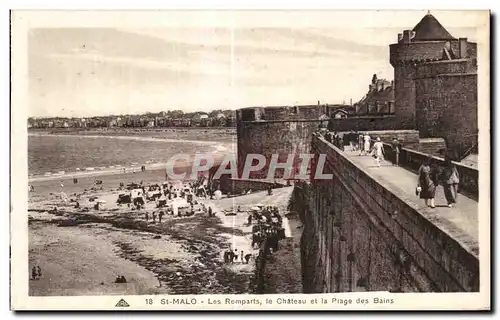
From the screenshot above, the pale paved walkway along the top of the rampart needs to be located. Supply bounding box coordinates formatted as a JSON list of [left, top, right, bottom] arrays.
[[345, 151, 476, 245]]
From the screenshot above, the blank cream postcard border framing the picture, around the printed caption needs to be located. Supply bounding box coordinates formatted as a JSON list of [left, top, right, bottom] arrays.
[[11, 11, 491, 310]]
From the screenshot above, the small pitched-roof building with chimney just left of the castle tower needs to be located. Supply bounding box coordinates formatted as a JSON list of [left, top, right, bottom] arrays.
[[354, 74, 394, 115]]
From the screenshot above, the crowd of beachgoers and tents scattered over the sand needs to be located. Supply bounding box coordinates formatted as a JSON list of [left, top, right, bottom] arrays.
[[29, 160, 292, 283]]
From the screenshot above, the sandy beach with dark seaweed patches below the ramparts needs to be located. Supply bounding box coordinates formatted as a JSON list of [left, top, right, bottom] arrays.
[[28, 166, 292, 296]]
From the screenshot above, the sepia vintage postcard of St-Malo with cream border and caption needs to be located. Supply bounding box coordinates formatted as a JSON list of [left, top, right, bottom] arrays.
[[10, 9, 491, 311]]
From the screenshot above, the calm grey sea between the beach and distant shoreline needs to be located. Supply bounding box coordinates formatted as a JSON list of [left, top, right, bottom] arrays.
[[28, 134, 232, 177]]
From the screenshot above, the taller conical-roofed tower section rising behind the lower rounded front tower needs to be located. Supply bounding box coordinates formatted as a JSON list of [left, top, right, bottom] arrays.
[[390, 13, 458, 129]]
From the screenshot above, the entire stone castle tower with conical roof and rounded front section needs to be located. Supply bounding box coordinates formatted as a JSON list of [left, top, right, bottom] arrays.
[[390, 13, 478, 158]]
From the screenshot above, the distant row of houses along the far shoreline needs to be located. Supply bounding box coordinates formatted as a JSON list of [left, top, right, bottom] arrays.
[[28, 112, 236, 128]]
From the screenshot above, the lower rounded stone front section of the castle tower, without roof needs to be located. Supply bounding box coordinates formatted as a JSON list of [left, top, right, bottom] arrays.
[[415, 60, 478, 154]]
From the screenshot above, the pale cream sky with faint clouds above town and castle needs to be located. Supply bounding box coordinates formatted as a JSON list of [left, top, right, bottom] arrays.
[[28, 11, 477, 117]]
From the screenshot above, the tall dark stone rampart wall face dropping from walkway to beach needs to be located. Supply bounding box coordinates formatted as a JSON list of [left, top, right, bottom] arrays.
[[297, 137, 479, 293]]
